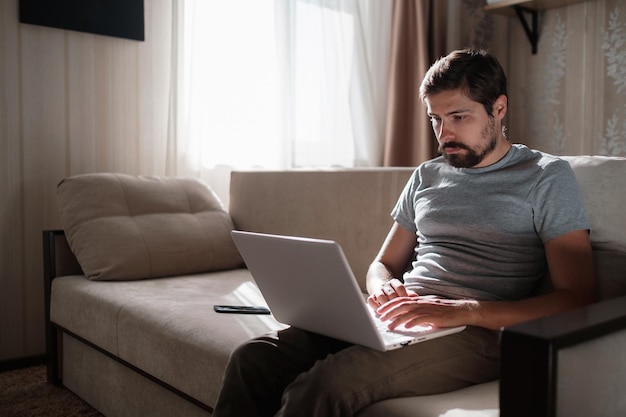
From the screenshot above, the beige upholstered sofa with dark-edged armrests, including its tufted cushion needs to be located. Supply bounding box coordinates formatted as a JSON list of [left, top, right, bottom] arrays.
[[43, 156, 626, 417]]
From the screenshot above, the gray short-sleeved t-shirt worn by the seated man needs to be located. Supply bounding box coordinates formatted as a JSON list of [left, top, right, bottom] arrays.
[[391, 145, 589, 300]]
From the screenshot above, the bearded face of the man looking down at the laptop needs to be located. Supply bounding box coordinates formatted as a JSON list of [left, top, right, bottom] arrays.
[[425, 90, 508, 168]]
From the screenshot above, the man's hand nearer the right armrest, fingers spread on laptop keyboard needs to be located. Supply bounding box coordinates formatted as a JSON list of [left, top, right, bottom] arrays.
[[370, 296, 480, 330]]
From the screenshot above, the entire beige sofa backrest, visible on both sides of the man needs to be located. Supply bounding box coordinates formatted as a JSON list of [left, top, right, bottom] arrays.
[[230, 156, 626, 299]]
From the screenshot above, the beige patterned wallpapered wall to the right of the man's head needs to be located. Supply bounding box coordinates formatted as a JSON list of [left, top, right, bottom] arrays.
[[458, 0, 626, 156]]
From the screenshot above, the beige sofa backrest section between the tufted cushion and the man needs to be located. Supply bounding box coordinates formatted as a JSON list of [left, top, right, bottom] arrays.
[[229, 168, 413, 289]]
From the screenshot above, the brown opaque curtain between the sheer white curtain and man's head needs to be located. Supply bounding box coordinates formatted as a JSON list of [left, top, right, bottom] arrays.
[[383, 0, 447, 166]]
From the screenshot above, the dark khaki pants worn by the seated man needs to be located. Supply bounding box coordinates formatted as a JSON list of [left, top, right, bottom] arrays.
[[213, 327, 499, 417]]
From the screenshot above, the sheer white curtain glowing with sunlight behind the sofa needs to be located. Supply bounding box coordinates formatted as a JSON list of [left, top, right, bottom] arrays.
[[170, 0, 392, 198]]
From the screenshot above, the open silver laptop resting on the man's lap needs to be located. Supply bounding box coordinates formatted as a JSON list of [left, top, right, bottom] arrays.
[[232, 230, 465, 351]]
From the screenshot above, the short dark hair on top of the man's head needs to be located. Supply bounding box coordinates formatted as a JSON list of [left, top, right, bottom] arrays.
[[419, 49, 507, 116]]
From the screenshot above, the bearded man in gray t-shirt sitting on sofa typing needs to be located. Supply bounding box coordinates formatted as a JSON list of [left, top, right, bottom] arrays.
[[214, 50, 594, 417]]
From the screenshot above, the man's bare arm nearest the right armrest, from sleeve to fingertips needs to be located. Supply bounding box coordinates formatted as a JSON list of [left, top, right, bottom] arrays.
[[370, 230, 595, 329]]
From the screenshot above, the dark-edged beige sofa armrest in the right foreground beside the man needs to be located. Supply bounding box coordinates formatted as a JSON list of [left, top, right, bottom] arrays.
[[500, 297, 626, 417]]
